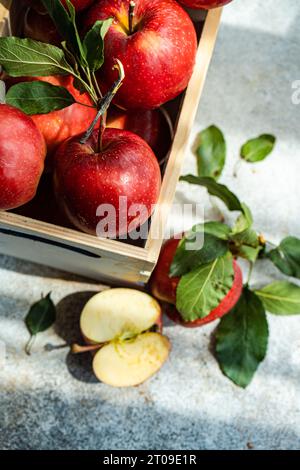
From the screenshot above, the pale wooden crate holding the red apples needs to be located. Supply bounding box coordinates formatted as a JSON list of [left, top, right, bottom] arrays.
[[0, 0, 222, 283]]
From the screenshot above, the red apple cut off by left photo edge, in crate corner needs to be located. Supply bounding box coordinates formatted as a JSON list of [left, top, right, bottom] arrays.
[[0, 104, 46, 210]]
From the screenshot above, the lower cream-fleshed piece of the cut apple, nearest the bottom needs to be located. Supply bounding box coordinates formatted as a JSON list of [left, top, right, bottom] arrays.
[[93, 332, 170, 387]]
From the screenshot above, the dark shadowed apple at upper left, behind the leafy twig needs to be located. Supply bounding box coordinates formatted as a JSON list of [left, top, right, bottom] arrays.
[[23, 8, 62, 46]]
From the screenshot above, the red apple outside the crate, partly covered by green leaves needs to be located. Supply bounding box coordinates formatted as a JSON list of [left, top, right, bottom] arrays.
[[150, 238, 243, 328]]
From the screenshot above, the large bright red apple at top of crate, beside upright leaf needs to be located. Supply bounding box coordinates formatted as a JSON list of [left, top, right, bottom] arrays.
[[83, 0, 197, 110]]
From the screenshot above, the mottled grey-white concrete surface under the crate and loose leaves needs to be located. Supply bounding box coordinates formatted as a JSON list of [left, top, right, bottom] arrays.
[[0, 0, 300, 450]]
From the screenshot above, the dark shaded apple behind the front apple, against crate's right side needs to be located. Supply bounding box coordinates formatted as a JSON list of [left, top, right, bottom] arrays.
[[107, 107, 173, 161]]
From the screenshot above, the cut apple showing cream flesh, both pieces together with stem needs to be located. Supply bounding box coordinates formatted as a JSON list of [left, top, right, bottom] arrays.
[[78, 288, 170, 387]]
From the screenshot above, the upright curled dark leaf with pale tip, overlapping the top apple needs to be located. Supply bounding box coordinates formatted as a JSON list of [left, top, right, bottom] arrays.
[[83, 18, 113, 72]]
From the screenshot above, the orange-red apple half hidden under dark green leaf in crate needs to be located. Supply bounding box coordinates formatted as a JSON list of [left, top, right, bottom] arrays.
[[5, 75, 97, 168]]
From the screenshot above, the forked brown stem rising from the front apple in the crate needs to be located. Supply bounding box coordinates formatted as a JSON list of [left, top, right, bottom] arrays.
[[80, 59, 125, 146]]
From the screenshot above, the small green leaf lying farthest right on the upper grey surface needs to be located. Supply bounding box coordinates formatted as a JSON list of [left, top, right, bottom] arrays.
[[241, 134, 276, 163]]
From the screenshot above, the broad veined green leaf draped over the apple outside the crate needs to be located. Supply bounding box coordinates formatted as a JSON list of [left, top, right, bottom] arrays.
[[176, 253, 234, 321]]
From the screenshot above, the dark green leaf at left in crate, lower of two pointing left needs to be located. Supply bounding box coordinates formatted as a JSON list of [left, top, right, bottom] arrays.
[[6, 81, 76, 115]]
